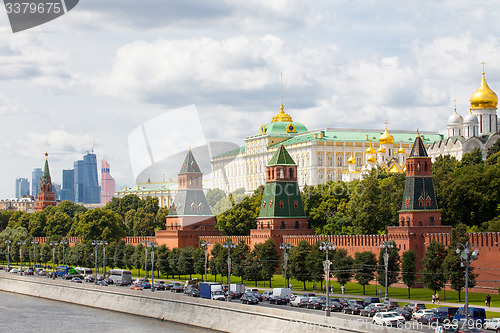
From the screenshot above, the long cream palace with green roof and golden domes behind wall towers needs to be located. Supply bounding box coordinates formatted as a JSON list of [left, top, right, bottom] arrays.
[[212, 104, 444, 193]]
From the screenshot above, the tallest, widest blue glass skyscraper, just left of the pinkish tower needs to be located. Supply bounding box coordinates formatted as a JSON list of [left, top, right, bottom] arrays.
[[74, 153, 101, 204]]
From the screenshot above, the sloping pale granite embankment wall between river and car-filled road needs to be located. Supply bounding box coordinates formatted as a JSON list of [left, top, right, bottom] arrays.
[[0, 272, 411, 333]]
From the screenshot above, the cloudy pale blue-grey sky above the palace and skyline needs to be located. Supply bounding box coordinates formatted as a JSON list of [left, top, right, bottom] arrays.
[[0, 0, 500, 199]]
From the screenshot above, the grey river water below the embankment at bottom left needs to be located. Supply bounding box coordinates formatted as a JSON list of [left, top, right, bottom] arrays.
[[0, 291, 216, 333]]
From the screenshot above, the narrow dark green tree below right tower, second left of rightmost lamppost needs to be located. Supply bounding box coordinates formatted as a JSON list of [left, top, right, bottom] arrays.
[[421, 240, 446, 292]]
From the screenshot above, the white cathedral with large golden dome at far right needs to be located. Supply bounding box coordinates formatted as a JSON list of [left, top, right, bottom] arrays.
[[427, 68, 500, 161]]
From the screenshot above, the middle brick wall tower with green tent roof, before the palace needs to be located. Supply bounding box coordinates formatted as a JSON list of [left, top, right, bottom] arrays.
[[257, 145, 309, 232]]
